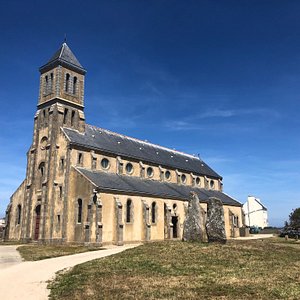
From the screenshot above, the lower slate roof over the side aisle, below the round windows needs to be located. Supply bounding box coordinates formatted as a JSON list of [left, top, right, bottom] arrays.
[[75, 167, 242, 206]]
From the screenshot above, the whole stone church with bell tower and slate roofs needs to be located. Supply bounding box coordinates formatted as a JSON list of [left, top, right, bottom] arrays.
[[5, 43, 243, 245]]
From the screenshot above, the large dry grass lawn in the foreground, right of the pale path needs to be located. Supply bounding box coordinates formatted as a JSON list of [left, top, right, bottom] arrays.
[[49, 238, 300, 300]]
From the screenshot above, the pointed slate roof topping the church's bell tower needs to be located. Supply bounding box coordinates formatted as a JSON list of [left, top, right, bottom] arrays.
[[40, 42, 86, 75]]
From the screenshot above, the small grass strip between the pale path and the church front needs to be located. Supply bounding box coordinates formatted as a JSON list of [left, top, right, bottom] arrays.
[[17, 244, 101, 261]]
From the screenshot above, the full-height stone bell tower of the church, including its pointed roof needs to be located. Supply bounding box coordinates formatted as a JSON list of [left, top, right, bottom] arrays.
[[21, 43, 86, 241]]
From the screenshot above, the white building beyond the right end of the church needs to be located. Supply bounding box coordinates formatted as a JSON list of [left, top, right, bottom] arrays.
[[243, 196, 268, 228]]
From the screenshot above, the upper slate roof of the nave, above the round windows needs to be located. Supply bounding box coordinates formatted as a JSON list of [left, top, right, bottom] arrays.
[[63, 125, 222, 179]]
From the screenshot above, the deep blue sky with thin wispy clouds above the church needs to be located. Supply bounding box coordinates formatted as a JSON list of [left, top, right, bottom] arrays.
[[0, 0, 300, 226]]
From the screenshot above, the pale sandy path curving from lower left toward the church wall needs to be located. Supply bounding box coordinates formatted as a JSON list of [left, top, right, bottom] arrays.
[[0, 245, 138, 300]]
